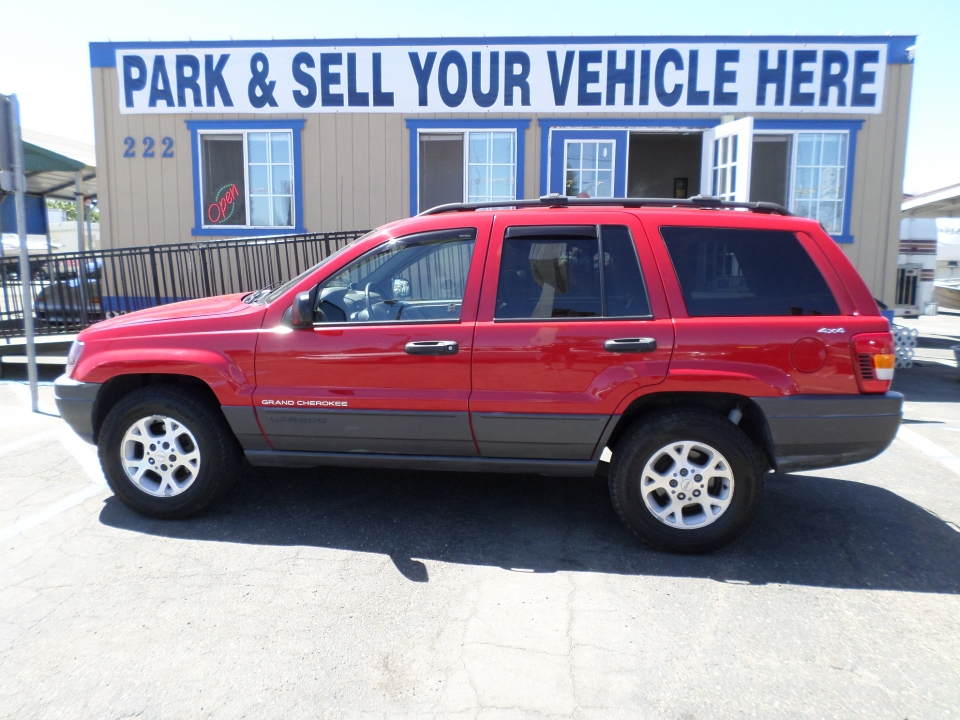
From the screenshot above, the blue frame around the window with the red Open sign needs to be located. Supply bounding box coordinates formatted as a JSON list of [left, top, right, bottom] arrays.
[[185, 120, 306, 237]]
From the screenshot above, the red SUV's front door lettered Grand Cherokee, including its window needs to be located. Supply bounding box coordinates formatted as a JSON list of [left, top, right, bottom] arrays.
[[254, 217, 490, 456]]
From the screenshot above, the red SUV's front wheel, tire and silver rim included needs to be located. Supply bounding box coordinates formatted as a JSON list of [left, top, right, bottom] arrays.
[[98, 386, 240, 519]]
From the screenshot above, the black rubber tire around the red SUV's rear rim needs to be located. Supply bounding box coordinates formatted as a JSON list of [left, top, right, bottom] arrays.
[[609, 410, 767, 553]]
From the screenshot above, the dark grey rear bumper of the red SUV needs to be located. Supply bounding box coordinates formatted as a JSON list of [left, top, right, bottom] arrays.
[[753, 392, 903, 472]]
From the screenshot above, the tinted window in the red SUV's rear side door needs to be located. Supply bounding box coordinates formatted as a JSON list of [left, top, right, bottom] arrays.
[[494, 225, 650, 320]]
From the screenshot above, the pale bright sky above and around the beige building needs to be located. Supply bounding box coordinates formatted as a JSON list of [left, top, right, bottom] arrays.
[[0, 0, 960, 193]]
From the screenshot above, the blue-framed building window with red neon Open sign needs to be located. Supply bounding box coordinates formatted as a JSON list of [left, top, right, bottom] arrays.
[[187, 120, 303, 236]]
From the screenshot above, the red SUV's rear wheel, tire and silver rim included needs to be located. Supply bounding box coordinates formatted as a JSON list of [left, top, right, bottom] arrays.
[[610, 410, 766, 553]]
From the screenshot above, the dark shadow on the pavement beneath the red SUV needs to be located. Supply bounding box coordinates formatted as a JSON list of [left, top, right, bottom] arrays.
[[100, 467, 960, 594]]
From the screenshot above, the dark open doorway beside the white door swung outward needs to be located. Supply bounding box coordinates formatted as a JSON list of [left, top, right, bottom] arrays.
[[627, 132, 703, 198]]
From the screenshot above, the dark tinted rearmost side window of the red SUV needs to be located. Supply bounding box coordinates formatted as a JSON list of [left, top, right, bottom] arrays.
[[660, 227, 840, 317]]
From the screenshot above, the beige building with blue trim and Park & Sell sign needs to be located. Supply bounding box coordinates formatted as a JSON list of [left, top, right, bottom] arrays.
[[90, 36, 915, 306]]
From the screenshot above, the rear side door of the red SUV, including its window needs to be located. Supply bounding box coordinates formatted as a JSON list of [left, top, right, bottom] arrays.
[[470, 210, 673, 460]]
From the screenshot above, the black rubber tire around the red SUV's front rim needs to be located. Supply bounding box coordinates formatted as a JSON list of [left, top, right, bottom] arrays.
[[97, 385, 241, 520]]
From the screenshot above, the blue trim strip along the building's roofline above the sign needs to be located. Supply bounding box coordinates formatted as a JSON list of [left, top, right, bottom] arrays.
[[90, 35, 917, 67]]
